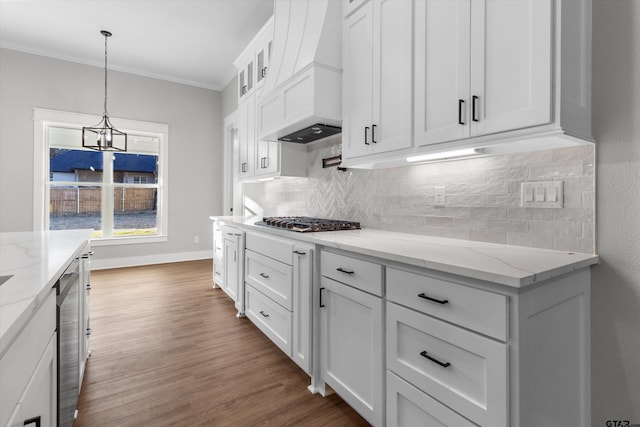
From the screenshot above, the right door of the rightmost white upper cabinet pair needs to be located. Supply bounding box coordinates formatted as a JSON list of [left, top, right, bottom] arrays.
[[470, 0, 553, 136]]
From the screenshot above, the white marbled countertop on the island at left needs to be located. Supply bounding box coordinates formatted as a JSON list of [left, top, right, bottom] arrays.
[[0, 230, 92, 354]]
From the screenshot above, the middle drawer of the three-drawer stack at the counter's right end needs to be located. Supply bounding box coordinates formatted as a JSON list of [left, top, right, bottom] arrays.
[[387, 302, 508, 427]]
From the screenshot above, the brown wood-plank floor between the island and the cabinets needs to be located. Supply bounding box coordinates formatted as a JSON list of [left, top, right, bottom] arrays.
[[74, 260, 368, 427]]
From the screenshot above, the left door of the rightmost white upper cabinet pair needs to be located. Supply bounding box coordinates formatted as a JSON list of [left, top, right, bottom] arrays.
[[414, 0, 470, 146]]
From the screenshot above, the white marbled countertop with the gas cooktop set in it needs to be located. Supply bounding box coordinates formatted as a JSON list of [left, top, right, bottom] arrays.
[[210, 216, 598, 288]]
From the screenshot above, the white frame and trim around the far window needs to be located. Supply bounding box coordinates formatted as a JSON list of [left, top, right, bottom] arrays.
[[33, 108, 169, 246]]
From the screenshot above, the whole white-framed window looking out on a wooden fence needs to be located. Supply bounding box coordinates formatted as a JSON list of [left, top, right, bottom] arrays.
[[34, 109, 168, 245]]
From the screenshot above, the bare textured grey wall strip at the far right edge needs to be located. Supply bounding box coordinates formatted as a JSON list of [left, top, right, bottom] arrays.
[[591, 0, 640, 427]]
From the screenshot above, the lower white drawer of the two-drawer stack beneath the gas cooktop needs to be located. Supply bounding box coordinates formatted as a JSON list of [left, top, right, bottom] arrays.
[[245, 286, 292, 357]]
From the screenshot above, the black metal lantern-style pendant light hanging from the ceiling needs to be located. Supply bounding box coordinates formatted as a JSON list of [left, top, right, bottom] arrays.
[[82, 30, 127, 151]]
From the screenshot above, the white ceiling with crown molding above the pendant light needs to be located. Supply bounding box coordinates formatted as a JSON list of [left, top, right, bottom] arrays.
[[0, 0, 273, 90]]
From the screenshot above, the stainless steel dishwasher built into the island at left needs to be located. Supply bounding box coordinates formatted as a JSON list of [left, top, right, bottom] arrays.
[[56, 259, 80, 427]]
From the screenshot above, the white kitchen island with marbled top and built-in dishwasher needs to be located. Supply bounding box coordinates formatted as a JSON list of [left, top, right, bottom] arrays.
[[0, 230, 92, 426]]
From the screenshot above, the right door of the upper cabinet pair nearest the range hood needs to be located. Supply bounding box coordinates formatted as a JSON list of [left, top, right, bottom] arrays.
[[372, 0, 413, 153]]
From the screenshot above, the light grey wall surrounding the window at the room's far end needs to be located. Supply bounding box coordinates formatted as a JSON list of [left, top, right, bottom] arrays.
[[0, 49, 223, 265]]
